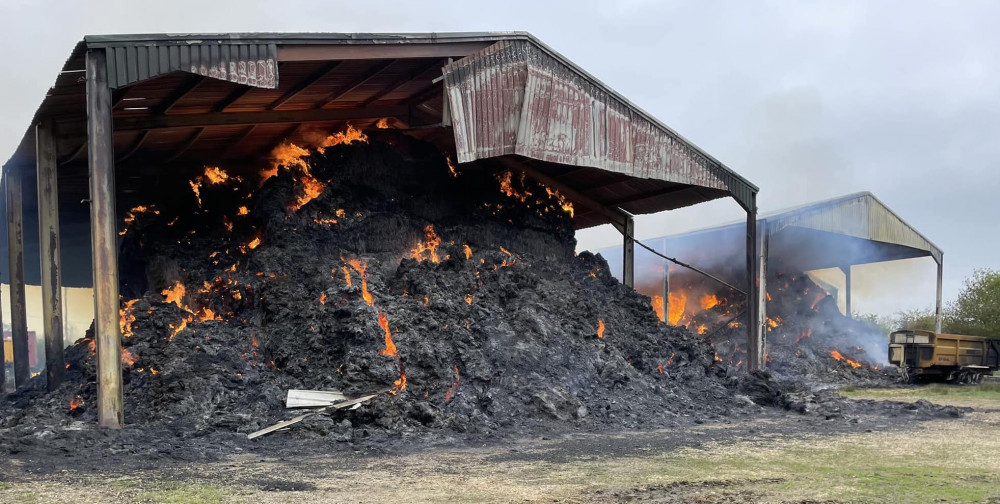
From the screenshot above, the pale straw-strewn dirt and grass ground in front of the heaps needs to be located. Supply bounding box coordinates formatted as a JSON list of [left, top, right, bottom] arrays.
[[0, 387, 1000, 504]]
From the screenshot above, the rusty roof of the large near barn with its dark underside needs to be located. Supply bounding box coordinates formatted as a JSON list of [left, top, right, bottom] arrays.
[[0, 32, 757, 286]]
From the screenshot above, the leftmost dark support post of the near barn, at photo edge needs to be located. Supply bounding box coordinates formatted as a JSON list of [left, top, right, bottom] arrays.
[[4, 166, 31, 389]]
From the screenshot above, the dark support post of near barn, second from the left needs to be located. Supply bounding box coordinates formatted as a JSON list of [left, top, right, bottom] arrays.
[[35, 120, 65, 390]]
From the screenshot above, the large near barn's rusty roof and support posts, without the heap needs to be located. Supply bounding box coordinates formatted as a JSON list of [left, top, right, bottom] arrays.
[[0, 32, 757, 427]]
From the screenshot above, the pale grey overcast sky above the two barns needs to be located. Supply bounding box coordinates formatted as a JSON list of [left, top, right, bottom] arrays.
[[0, 0, 1000, 311]]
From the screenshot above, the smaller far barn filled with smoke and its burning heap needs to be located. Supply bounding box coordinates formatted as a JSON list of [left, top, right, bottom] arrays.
[[604, 192, 943, 381]]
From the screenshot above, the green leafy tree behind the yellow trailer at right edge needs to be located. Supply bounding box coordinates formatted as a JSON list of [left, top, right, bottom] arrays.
[[948, 269, 1000, 339]]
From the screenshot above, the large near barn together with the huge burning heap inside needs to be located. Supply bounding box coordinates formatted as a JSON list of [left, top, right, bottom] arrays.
[[0, 33, 757, 435]]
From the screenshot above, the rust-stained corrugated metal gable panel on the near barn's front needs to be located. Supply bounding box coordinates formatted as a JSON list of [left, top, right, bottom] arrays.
[[444, 39, 757, 212]]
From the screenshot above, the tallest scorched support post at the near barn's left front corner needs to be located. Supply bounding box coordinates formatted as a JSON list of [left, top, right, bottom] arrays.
[[87, 49, 125, 429]]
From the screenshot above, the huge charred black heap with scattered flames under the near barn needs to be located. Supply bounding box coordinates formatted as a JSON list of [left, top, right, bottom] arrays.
[[0, 129, 756, 452]]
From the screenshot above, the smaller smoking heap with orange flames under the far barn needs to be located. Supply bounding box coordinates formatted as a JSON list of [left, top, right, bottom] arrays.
[[652, 273, 899, 387]]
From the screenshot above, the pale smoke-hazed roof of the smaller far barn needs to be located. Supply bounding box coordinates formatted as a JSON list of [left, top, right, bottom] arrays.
[[602, 192, 942, 286]]
